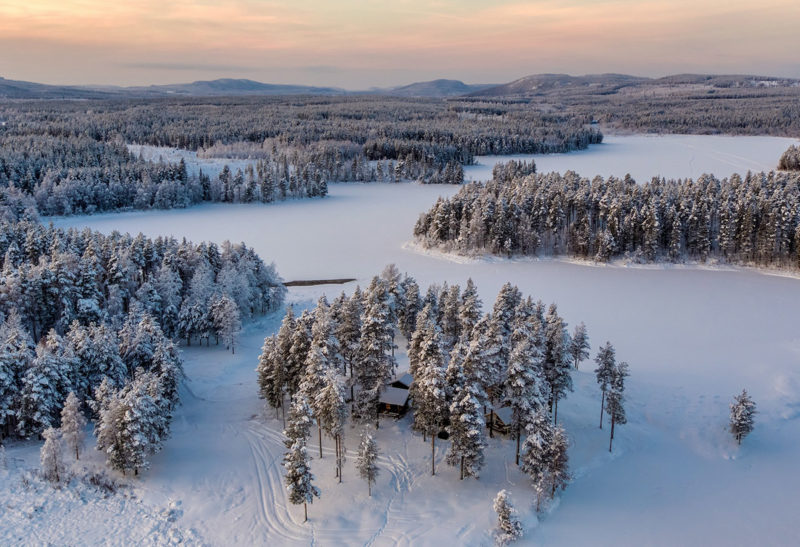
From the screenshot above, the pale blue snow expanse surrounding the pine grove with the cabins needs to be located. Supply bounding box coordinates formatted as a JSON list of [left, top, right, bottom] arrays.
[[6, 137, 800, 545]]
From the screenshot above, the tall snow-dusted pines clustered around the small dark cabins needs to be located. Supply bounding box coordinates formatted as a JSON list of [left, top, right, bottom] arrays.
[[257, 265, 627, 520]]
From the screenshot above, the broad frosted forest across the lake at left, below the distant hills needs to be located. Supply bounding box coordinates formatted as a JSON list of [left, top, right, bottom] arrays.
[[0, 97, 602, 215]]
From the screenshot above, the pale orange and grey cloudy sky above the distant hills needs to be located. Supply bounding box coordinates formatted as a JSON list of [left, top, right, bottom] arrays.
[[0, 0, 800, 89]]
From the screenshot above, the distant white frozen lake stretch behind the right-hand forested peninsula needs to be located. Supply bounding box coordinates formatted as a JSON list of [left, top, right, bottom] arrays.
[[464, 135, 798, 182]]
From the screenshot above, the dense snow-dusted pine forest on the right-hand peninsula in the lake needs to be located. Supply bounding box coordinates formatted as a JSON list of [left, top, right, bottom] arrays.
[[414, 168, 800, 268]]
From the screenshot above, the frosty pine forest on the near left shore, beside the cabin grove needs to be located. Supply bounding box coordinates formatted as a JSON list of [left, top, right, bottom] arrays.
[[0, 221, 286, 471]]
